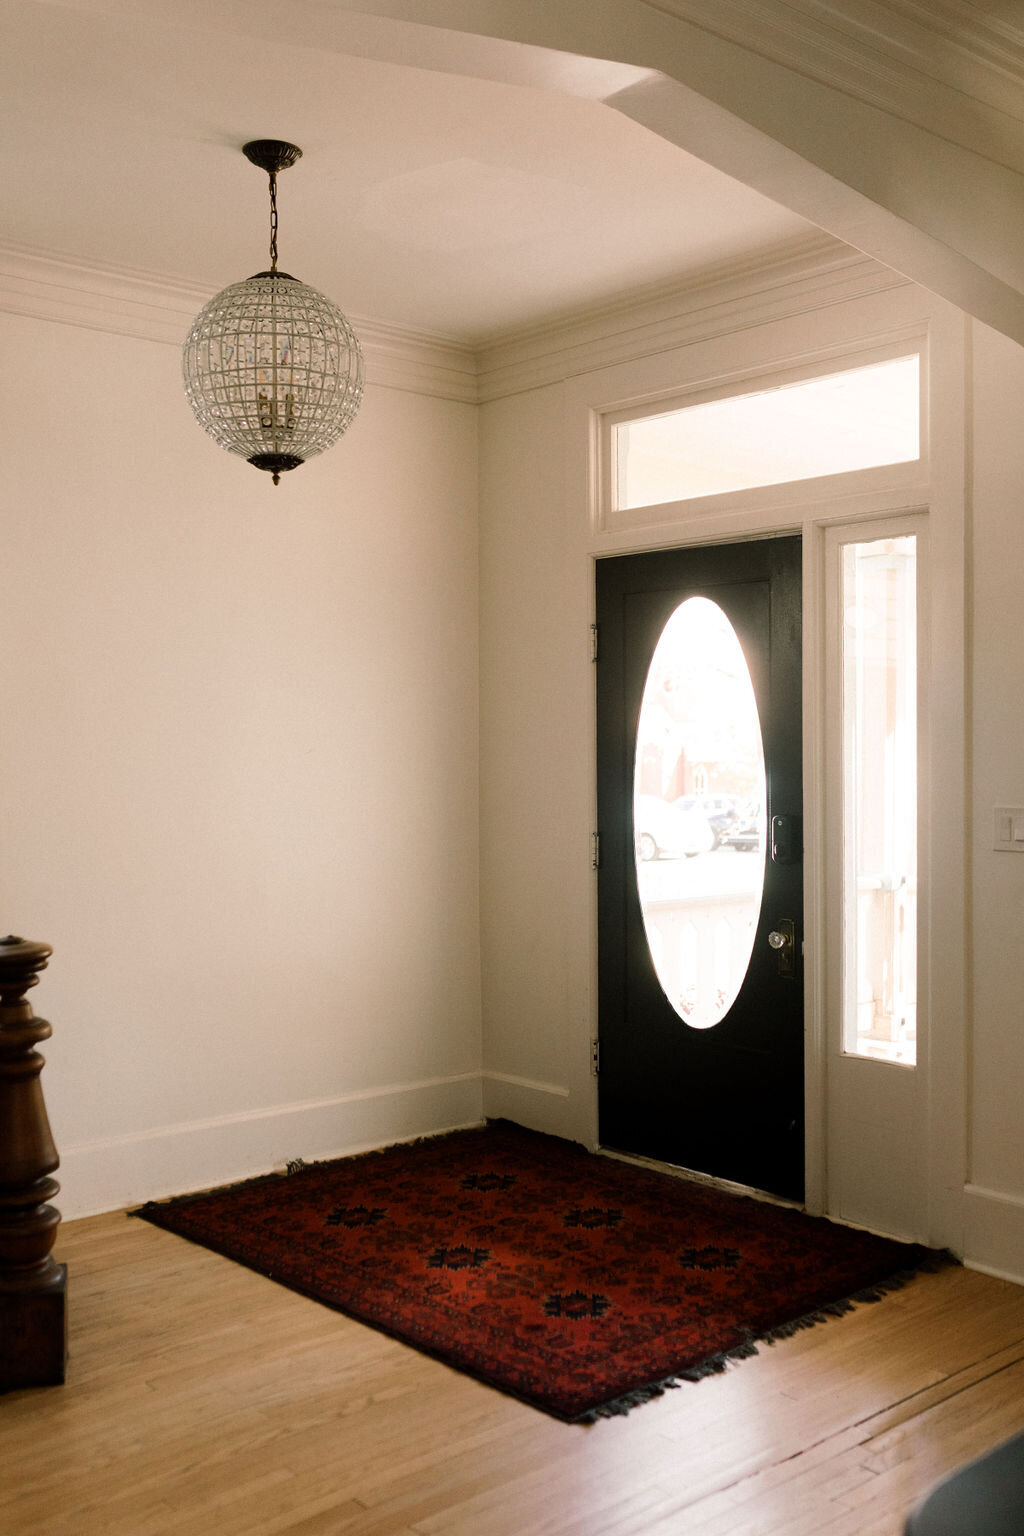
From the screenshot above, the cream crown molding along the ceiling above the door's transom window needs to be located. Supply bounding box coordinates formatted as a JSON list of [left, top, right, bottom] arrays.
[[477, 235, 907, 401]]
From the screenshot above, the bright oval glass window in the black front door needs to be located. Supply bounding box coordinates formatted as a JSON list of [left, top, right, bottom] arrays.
[[633, 598, 766, 1029]]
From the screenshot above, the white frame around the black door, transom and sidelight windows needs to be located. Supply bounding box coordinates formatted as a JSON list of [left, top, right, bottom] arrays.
[[565, 287, 967, 1250]]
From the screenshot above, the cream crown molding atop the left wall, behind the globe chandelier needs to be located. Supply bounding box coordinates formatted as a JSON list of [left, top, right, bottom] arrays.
[[0, 246, 476, 402]]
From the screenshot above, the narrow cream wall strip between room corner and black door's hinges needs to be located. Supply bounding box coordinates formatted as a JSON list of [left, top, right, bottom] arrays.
[[481, 386, 594, 1143]]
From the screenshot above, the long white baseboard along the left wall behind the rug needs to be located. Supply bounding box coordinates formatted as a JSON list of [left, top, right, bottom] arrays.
[[55, 1072, 484, 1221]]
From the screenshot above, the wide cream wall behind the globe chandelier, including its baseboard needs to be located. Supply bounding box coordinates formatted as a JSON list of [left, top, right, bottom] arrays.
[[0, 315, 481, 1217]]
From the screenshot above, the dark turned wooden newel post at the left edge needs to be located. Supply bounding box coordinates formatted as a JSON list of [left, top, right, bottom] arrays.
[[0, 934, 68, 1392]]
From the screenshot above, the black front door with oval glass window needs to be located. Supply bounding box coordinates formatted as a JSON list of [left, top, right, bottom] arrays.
[[597, 538, 804, 1200]]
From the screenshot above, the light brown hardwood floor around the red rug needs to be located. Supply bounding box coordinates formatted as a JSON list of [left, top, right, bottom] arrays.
[[0, 1215, 1024, 1536]]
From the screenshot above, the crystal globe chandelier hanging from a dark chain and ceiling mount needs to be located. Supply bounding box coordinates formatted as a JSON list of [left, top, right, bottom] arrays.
[[183, 138, 364, 485]]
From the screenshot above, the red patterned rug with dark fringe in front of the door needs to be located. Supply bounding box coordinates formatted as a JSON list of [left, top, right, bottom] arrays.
[[134, 1121, 936, 1421]]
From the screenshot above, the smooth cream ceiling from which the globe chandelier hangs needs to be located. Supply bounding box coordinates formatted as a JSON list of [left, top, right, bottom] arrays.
[[0, 0, 815, 344]]
